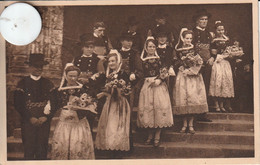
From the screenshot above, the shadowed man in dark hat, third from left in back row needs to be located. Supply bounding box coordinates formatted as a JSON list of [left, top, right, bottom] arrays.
[[147, 8, 177, 47]]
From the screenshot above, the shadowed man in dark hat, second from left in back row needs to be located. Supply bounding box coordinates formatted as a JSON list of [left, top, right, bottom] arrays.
[[120, 16, 144, 52]]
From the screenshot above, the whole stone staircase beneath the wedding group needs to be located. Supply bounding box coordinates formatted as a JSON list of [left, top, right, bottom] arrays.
[[7, 110, 254, 160]]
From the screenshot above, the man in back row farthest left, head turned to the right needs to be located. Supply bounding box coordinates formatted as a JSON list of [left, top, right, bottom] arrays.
[[86, 22, 113, 59]]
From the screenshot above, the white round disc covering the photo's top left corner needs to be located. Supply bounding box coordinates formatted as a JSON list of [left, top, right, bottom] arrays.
[[0, 3, 42, 46]]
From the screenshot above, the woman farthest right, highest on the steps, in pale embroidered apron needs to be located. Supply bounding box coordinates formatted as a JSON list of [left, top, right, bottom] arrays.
[[209, 21, 234, 112]]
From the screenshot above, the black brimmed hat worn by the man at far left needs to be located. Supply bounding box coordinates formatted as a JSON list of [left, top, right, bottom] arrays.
[[24, 53, 49, 67]]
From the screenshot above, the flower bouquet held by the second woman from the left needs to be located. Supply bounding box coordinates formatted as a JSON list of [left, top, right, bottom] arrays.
[[105, 79, 131, 96]]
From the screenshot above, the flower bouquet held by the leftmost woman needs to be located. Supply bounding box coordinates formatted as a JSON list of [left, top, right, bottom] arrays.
[[65, 93, 97, 114]]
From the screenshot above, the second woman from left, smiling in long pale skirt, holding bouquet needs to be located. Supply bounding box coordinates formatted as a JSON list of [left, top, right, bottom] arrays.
[[95, 50, 130, 155]]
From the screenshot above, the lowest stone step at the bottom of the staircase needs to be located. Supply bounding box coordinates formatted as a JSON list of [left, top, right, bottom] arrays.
[[7, 142, 254, 160]]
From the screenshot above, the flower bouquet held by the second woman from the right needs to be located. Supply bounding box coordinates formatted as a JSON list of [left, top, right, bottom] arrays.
[[181, 52, 203, 68]]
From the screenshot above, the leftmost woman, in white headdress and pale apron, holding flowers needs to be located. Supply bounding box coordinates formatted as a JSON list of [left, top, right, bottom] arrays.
[[51, 64, 96, 160]]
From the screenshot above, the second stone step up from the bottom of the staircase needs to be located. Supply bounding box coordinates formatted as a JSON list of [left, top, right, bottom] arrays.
[[7, 129, 254, 152]]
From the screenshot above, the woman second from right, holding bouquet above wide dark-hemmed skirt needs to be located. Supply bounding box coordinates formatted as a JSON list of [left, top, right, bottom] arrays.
[[173, 28, 208, 134]]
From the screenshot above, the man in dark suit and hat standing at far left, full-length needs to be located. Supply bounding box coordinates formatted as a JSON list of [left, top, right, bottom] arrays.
[[14, 54, 54, 160]]
